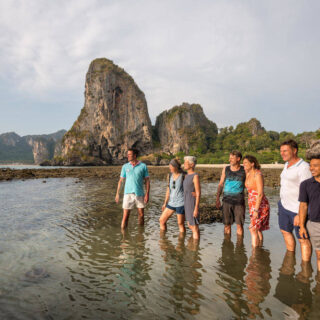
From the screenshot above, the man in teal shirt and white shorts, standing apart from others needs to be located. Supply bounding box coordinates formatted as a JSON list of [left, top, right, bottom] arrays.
[[115, 149, 150, 229]]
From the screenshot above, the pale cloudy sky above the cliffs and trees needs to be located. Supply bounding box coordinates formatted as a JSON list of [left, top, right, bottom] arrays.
[[0, 0, 320, 135]]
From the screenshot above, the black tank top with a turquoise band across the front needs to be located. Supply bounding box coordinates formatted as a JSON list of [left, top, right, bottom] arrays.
[[223, 166, 246, 204]]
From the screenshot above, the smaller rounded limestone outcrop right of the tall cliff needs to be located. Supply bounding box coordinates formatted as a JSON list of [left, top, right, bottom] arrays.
[[155, 103, 218, 154]]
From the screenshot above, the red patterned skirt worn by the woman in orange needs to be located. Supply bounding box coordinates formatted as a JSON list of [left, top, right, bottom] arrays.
[[248, 188, 270, 231]]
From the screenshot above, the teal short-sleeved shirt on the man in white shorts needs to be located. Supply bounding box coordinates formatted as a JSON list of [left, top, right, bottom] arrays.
[[120, 162, 149, 197]]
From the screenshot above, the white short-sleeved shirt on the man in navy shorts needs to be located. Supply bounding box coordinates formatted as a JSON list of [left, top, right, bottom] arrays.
[[280, 159, 312, 213]]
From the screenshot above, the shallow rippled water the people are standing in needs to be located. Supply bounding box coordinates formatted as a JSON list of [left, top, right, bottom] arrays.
[[0, 178, 320, 319]]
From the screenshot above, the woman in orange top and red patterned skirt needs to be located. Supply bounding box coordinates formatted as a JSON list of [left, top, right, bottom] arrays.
[[243, 155, 270, 247]]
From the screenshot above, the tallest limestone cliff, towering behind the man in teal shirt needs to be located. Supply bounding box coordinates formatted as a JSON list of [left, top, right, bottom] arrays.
[[55, 58, 152, 165]]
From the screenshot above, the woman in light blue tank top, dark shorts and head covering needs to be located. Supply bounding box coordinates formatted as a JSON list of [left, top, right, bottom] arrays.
[[159, 159, 186, 232]]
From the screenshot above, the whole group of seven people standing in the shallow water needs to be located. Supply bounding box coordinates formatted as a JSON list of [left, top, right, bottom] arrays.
[[115, 140, 320, 271]]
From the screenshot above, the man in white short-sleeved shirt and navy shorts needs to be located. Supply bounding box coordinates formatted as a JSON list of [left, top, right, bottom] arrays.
[[278, 140, 312, 261]]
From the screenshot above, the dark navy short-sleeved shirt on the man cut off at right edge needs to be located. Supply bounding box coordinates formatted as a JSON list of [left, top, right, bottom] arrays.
[[299, 177, 320, 222]]
